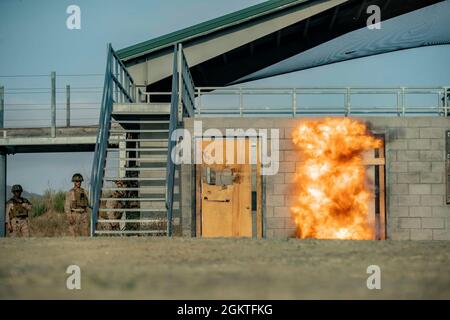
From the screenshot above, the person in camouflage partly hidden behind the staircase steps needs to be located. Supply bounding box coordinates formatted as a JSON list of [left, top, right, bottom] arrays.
[[100, 180, 127, 231]]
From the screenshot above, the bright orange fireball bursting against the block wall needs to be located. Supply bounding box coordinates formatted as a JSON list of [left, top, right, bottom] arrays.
[[291, 118, 382, 239]]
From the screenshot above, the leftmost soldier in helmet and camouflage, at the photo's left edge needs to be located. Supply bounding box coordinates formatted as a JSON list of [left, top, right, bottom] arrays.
[[6, 184, 31, 237]]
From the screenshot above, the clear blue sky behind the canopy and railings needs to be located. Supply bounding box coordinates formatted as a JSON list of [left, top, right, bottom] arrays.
[[0, 0, 450, 193]]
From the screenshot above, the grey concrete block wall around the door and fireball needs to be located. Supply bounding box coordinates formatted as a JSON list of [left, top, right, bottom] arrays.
[[181, 117, 450, 240]]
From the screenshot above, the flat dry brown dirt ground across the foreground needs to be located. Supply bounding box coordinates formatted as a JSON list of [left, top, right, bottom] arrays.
[[0, 237, 450, 299]]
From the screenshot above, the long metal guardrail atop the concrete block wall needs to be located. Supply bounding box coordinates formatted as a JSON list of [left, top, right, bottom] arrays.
[[195, 87, 450, 117]]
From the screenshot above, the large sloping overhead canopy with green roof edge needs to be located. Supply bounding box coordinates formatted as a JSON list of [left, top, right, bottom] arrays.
[[118, 0, 450, 91]]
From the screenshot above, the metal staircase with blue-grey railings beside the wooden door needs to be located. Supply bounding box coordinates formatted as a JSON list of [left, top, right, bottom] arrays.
[[91, 45, 194, 236]]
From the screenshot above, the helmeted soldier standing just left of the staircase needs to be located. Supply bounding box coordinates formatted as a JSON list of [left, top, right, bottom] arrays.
[[64, 173, 89, 236]]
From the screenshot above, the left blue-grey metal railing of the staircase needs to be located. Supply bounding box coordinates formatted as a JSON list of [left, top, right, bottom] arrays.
[[91, 44, 136, 236]]
